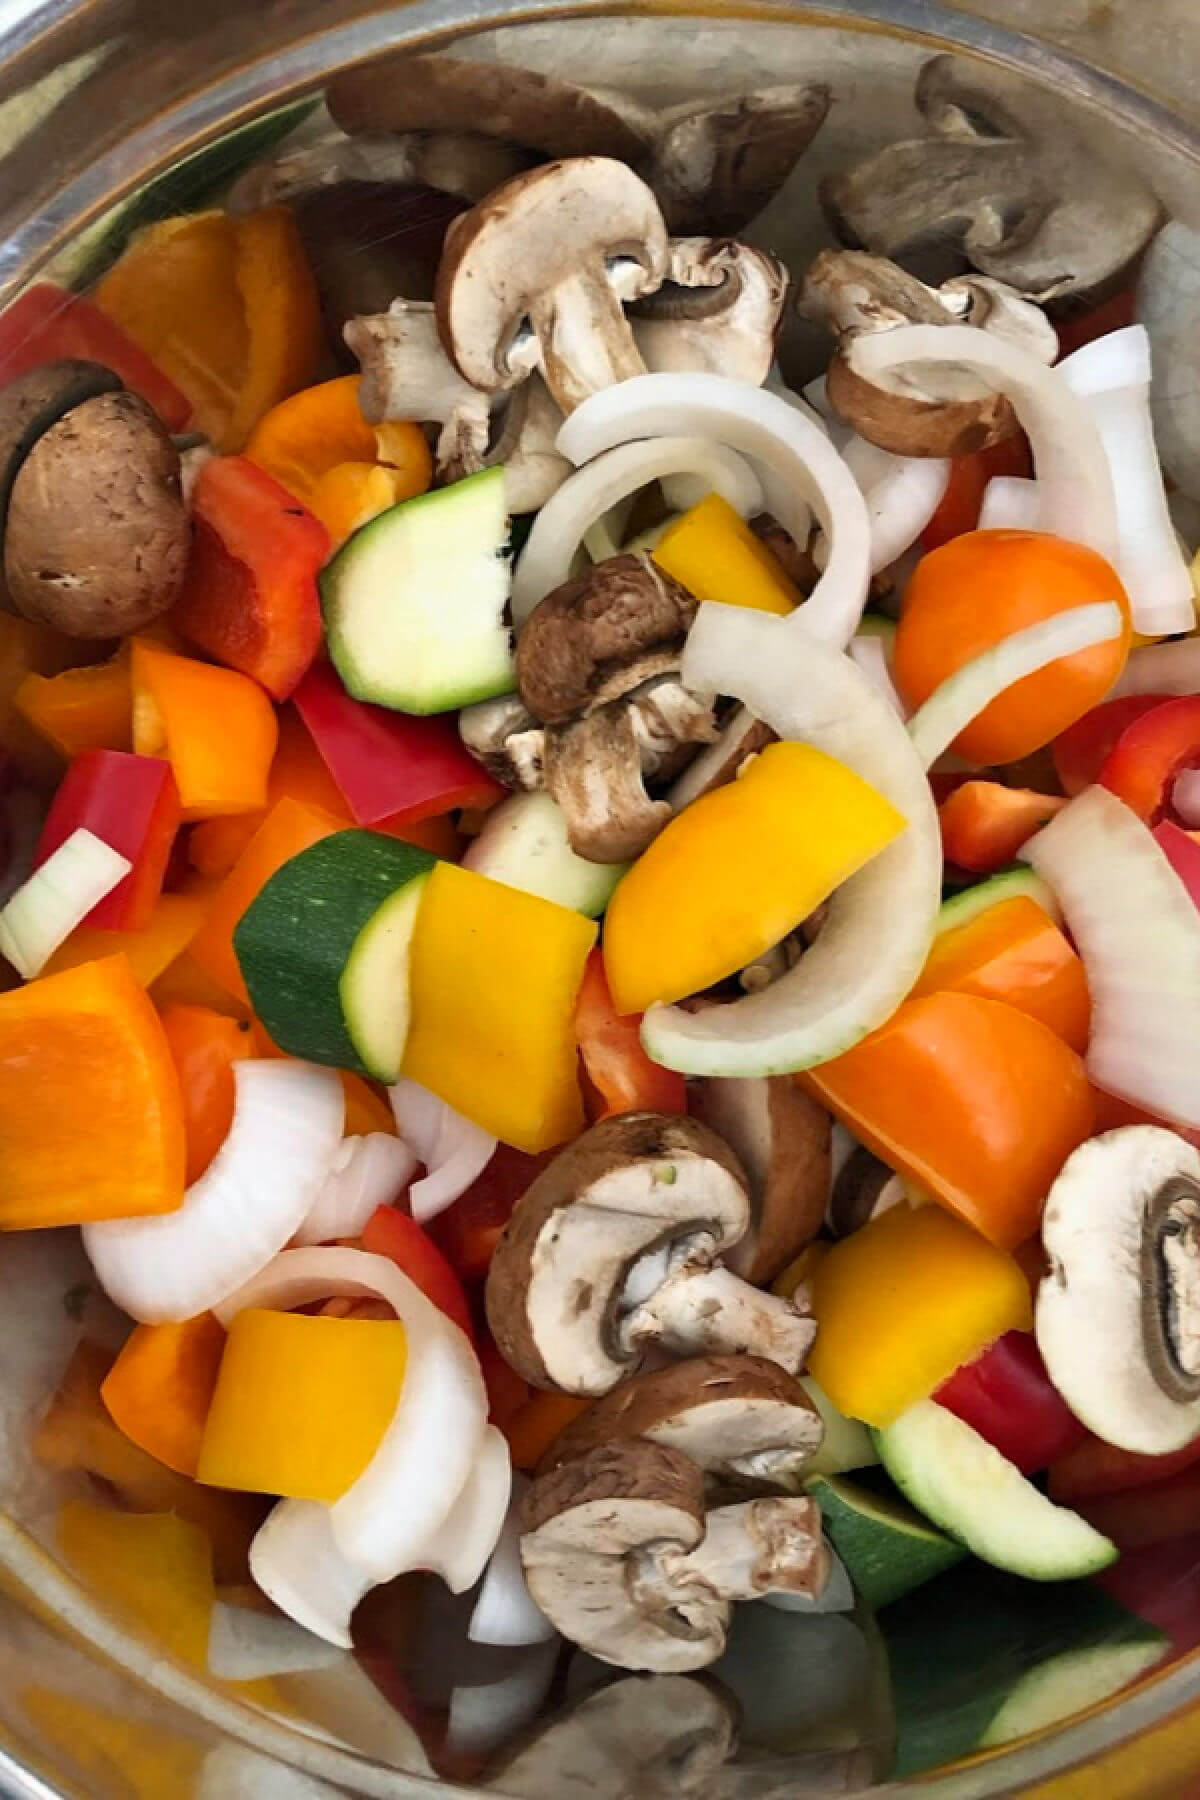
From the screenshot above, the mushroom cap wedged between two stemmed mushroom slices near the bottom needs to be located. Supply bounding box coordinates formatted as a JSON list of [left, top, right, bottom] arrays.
[[540, 1355, 824, 1487]]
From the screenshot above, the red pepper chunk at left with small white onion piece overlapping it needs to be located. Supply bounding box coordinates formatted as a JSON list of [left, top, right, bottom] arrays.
[[34, 751, 180, 931]]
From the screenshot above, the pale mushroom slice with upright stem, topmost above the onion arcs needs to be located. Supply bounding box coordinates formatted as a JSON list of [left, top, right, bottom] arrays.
[[435, 157, 667, 412]]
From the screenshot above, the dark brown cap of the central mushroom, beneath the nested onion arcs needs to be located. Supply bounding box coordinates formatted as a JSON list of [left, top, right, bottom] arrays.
[[516, 554, 696, 725]]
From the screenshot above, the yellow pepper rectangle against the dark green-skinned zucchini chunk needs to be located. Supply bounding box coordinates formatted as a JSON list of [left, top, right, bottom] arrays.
[[403, 862, 596, 1154]]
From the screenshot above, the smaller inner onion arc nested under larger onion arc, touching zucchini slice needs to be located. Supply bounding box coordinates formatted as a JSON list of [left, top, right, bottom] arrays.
[[513, 435, 763, 626]]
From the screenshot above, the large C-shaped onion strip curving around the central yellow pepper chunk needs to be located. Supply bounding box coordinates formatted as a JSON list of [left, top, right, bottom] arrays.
[[642, 605, 941, 1075]]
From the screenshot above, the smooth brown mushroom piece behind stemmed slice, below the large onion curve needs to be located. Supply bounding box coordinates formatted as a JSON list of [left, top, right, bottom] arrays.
[[691, 1075, 833, 1285]]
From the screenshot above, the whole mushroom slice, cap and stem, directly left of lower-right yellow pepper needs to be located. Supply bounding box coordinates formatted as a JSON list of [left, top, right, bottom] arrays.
[[486, 1112, 815, 1395]]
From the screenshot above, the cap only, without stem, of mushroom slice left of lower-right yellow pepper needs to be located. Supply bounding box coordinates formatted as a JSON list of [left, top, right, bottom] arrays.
[[486, 1112, 750, 1395]]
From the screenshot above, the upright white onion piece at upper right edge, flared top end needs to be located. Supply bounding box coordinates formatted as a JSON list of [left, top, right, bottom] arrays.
[[1058, 326, 1196, 637]]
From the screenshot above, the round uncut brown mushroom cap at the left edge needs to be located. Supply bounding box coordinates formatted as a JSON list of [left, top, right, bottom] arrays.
[[4, 392, 191, 637]]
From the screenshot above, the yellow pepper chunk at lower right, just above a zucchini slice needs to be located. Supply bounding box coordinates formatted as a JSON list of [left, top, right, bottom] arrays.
[[808, 1206, 1033, 1426]]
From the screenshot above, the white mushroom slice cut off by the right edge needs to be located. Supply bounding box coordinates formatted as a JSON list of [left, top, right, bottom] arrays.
[[1036, 1125, 1200, 1456]]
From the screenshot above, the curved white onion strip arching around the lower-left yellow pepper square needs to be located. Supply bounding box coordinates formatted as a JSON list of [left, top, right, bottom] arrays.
[[216, 1246, 488, 1580]]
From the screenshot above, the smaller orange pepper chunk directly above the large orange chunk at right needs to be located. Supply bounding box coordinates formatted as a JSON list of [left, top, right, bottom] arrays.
[[909, 895, 1092, 1055]]
